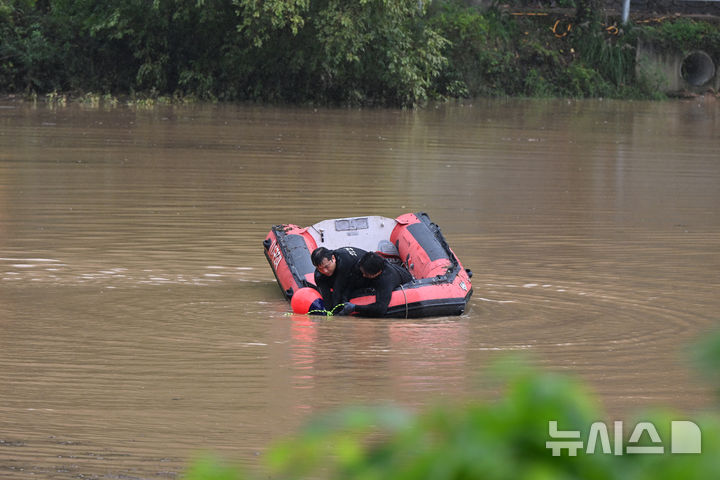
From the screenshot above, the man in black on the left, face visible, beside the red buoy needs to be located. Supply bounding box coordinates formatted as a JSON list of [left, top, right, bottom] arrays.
[[310, 247, 367, 310]]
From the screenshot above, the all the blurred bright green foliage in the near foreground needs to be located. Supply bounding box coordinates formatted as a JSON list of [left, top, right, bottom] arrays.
[[187, 335, 720, 480]]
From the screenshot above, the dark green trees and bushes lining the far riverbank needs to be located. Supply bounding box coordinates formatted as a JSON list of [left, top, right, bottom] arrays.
[[0, 0, 720, 106]]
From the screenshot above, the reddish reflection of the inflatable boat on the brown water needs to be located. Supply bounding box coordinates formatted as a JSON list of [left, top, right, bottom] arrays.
[[290, 314, 472, 409]]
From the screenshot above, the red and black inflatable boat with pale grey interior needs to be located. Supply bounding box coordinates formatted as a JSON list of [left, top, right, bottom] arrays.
[[263, 213, 472, 318]]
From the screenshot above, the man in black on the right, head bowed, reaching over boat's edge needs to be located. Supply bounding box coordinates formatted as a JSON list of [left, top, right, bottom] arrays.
[[341, 252, 412, 317]]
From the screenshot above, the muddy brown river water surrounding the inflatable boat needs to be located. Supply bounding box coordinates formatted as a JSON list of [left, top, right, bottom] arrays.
[[0, 98, 720, 480]]
